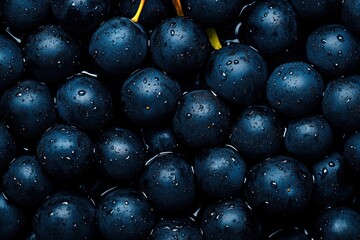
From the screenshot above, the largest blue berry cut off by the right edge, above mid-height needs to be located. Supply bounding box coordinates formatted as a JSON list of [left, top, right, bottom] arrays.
[[322, 75, 360, 132]]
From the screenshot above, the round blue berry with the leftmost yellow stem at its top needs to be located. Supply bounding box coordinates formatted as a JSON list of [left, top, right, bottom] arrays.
[[89, 17, 147, 76]]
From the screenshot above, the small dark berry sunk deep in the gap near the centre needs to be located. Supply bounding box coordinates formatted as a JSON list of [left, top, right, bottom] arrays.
[[142, 126, 179, 154]]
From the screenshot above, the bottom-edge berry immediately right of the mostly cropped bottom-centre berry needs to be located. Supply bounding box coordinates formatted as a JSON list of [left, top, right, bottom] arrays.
[[201, 198, 263, 240]]
